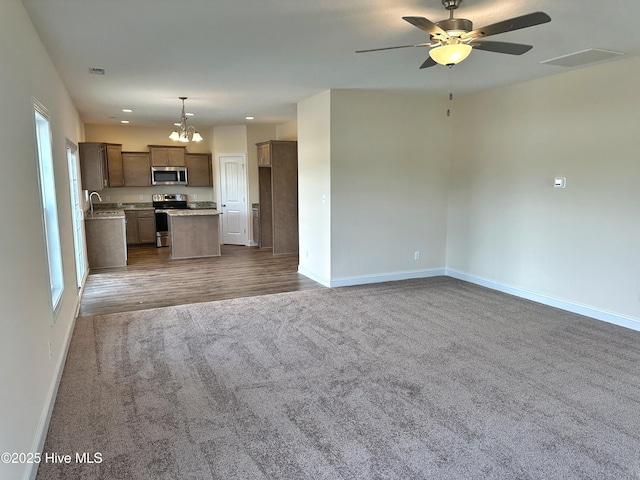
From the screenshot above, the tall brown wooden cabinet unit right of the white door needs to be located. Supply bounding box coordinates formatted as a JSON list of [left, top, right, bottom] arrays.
[[256, 140, 298, 255]]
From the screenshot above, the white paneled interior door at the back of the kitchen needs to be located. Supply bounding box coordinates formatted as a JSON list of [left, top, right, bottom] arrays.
[[218, 154, 249, 245]]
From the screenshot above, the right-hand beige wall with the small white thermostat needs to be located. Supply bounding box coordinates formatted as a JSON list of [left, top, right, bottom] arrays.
[[447, 58, 640, 325]]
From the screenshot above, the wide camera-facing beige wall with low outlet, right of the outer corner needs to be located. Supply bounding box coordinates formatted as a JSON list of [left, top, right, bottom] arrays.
[[331, 90, 449, 281]]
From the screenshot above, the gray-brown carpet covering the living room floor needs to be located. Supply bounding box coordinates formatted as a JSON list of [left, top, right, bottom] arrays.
[[37, 277, 640, 480]]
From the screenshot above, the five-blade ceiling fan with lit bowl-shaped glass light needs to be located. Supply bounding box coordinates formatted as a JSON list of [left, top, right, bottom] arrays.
[[356, 0, 551, 68]]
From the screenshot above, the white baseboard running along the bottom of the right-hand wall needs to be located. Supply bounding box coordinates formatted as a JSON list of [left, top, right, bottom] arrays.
[[445, 268, 640, 331]]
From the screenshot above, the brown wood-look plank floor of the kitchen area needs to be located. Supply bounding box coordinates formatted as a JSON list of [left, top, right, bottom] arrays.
[[79, 245, 324, 317]]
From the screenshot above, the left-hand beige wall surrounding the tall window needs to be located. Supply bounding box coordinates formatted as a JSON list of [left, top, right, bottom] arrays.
[[0, 0, 83, 478]]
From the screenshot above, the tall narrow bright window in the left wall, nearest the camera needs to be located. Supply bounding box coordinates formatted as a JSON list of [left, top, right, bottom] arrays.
[[34, 101, 64, 318]]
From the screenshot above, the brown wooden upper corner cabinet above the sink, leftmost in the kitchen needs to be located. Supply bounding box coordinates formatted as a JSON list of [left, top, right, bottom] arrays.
[[79, 142, 124, 191]]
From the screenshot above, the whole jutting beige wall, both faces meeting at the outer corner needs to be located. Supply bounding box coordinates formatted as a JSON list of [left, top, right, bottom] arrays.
[[298, 90, 449, 285]]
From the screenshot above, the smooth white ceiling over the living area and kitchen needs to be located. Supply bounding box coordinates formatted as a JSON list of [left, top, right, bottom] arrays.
[[23, 0, 640, 128]]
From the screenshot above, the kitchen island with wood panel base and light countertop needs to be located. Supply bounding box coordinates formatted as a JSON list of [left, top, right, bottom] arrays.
[[156, 209, 221, 259]]
